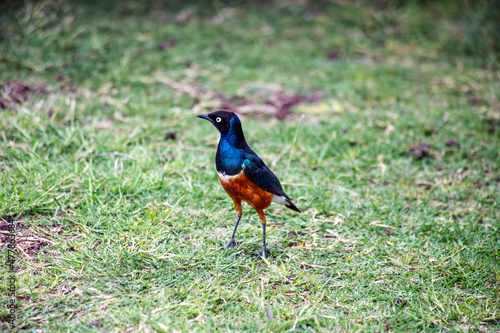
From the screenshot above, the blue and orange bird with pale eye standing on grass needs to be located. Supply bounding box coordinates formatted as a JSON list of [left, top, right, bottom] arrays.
[[197, 111, 300, 259]]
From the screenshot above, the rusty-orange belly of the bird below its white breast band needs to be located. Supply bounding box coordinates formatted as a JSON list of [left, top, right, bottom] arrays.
[[219, 171, 273, 210]]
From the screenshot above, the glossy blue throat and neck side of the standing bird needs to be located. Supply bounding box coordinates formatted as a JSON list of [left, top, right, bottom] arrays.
[[215, 117, 247, 175]]
